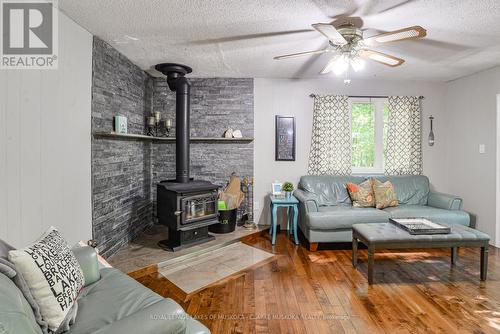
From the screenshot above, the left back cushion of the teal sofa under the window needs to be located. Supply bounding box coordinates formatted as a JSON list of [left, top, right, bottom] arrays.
[[299, 175, 366, 205]]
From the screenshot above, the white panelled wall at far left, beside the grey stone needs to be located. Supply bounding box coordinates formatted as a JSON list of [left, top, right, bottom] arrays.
[[0, 13, 92, 247]]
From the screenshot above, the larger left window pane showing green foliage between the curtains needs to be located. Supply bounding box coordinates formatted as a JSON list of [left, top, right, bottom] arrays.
[[352, 103, 375, 167]]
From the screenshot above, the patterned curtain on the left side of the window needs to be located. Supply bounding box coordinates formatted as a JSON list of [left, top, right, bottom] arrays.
[[309, 95, 352, 175]]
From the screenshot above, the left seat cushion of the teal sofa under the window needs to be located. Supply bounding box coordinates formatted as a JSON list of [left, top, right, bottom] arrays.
[[306, 205, 389, 230]]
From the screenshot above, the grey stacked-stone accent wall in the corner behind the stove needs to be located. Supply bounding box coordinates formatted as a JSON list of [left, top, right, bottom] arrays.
[[92, 37, 254, 256]]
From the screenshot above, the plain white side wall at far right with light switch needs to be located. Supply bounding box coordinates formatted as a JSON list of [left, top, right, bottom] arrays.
[[445, 68, 500, 246]]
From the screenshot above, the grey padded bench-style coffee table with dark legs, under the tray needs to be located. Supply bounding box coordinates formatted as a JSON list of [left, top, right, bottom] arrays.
[[352, 223, 490, 284]]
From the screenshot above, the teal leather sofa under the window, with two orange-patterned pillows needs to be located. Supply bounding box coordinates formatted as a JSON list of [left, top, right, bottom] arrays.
[[294, 175, 470, 250]]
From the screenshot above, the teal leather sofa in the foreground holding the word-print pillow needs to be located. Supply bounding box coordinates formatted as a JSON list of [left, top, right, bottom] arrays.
[[0, 247, 210, 334]]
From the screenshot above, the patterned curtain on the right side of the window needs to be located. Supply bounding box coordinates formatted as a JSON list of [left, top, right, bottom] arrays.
[[385, 96, 422, 175]]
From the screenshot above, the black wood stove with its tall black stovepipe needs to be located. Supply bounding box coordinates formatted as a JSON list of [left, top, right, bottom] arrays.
[[155, 63, 218, 251]]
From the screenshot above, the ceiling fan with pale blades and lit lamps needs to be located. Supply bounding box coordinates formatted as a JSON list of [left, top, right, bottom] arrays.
[[274, 23, 427, 75]]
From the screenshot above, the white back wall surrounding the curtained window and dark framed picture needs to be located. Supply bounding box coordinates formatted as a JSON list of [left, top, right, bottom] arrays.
[[254, 78, 448, 224]]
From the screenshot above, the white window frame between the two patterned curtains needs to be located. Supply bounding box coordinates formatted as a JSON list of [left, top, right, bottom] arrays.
[[349, 97, 387, 175]]
